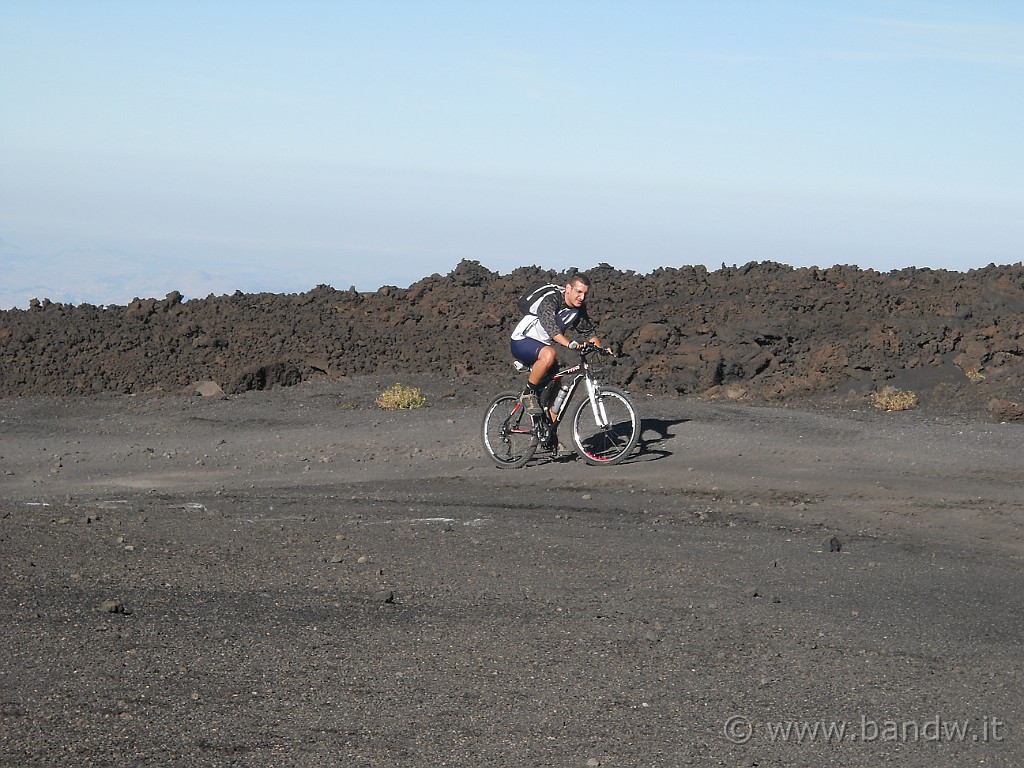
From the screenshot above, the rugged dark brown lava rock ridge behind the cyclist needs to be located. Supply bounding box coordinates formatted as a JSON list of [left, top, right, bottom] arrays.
[[0, 260, 1024, 417]]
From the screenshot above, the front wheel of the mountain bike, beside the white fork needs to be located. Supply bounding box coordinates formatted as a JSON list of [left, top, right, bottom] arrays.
[[572, 387, 640, 464]]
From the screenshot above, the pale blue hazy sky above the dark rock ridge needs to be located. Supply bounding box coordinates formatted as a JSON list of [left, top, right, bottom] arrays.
[[0, 0, 1024, 308]]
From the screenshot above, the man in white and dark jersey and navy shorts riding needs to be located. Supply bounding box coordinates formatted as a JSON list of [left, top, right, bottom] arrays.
[[511, 272, 601, 416]]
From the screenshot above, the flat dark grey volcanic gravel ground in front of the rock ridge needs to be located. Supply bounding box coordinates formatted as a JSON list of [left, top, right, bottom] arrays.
[[0, 378, 1024, 767]]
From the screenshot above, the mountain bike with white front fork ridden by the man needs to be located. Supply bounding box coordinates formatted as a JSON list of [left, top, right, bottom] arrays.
[[483, 344, 640, 469]]
